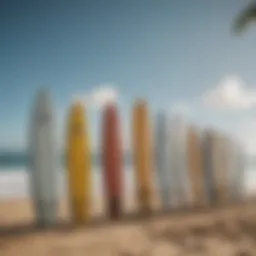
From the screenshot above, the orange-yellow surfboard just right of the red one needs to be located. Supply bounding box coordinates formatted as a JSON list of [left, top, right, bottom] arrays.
[[132, 99, 153, 213]]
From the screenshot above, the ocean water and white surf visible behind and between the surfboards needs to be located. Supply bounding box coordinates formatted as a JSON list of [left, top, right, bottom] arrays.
[[0, 152, 256, 200]]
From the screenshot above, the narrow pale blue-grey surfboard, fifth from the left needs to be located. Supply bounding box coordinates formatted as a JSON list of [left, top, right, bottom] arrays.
[[154, 111, 171, 209]]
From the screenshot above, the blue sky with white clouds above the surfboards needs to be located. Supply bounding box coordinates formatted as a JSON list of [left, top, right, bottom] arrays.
[[0, 0, 256, 154]]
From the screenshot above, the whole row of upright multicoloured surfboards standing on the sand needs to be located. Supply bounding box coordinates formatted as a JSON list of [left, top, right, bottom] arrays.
[[29, 91, 244, 225]]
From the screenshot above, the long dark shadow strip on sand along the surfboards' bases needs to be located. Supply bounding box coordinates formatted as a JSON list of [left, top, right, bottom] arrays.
[[0, 199, 256, 237]]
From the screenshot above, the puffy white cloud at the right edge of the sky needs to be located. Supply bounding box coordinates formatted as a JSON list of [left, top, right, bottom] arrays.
[[203, 76, 256, 109]]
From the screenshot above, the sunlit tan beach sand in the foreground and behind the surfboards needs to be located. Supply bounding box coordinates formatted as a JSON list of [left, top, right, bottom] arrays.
[[0, 199, 256, 256]]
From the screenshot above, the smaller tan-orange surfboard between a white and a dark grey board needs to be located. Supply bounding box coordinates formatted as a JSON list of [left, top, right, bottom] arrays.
[[187, 126, 206, 206]]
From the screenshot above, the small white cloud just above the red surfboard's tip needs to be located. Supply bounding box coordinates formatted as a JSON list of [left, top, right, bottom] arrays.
[[73, 84, 119, 108]]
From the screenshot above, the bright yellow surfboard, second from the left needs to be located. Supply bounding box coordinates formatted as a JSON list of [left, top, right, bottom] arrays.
[[67, 103, 92, 223]]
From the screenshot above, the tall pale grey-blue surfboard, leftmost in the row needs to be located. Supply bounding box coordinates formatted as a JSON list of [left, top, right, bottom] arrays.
[[28, 90, 58, 226]]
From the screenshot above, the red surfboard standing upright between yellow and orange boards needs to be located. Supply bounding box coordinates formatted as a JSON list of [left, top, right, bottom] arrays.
[[102, 103, 123, 219]]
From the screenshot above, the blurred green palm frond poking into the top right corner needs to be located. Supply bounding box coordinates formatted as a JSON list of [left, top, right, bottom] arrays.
[[234, 1, 256, 32]]
